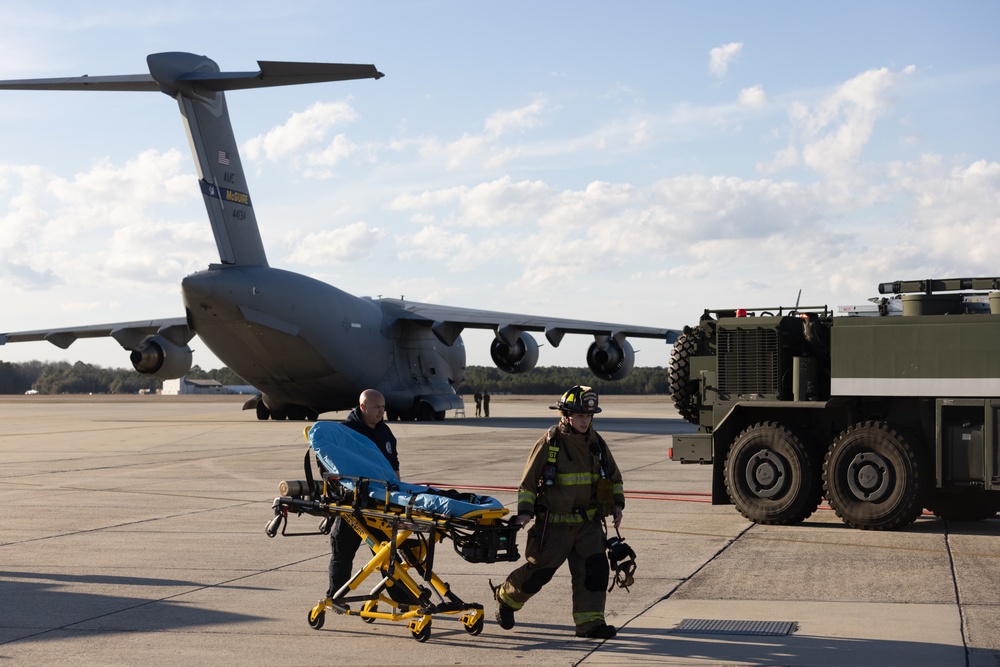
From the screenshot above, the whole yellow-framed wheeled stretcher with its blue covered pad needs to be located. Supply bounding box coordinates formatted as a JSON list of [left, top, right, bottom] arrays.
[[266, 422, 520, 642]]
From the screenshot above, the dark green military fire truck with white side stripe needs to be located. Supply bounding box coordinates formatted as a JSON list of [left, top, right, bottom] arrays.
[[670, 278, 1000, 530]]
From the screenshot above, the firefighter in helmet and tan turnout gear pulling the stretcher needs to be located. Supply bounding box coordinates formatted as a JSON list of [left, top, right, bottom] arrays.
[[490, 385, 625, 639]]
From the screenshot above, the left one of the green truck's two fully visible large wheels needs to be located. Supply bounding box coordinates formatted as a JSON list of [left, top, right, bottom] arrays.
[[724, 422, 822, 525]]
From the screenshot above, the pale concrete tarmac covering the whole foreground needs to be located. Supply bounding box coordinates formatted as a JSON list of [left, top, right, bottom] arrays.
[[0, 396, 1000, 667]]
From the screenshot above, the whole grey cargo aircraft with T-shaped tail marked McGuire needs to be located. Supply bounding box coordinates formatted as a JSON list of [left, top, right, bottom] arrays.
[[0, 52, 679, 420]]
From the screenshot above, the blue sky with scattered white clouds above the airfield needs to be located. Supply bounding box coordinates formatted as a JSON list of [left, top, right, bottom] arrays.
[[0, 1, 1000, 368]]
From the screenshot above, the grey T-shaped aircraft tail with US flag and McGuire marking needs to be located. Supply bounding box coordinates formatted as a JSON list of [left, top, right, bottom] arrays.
[[0, 52, 383, 266]]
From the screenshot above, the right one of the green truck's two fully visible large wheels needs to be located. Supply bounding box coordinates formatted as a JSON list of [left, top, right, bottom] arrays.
[[823, 421, 925, 530]]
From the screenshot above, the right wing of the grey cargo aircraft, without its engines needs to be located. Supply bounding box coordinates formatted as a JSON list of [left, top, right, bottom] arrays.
[[381, 299, 681, 347]]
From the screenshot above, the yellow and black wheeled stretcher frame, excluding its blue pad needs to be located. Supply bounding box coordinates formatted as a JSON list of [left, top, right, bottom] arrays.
[[266, 475, 519, 642]]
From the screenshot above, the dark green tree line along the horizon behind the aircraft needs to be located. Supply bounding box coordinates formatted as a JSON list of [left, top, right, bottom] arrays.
[[0, 361, 669, 396]]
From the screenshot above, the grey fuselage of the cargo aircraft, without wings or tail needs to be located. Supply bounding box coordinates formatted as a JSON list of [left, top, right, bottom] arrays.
[[181, 264, 465, 412]]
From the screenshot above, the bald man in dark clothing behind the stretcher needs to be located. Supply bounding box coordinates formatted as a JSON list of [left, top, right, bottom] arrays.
[[326, 389, 399, 598]]
